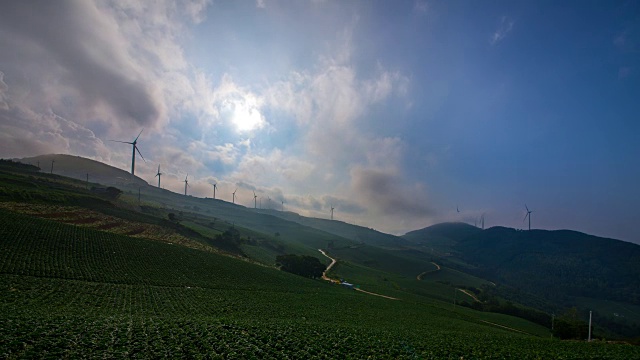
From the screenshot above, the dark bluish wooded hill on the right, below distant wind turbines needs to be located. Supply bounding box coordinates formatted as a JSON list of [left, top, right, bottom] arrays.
[[403, 223, 640, 336]]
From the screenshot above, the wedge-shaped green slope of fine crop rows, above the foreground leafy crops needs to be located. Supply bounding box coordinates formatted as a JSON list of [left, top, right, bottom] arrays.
[[0, 209, 317, 288]]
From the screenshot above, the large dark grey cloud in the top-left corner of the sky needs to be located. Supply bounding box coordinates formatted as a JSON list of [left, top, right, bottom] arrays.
[[0, 1, 161, 126]]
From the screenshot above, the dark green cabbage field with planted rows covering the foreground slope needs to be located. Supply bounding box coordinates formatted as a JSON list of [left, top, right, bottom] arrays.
[[0, 209, 640, 359]]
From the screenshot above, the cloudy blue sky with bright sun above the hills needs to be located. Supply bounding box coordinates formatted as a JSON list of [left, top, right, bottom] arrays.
[[0, 0, 640, 243]]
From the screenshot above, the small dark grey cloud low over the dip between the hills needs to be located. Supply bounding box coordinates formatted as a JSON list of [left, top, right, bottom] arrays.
[[351, 167, 433, 217]]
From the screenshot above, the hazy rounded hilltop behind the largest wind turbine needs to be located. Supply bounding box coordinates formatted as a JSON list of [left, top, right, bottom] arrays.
[[17, 154, 148, 186]]
